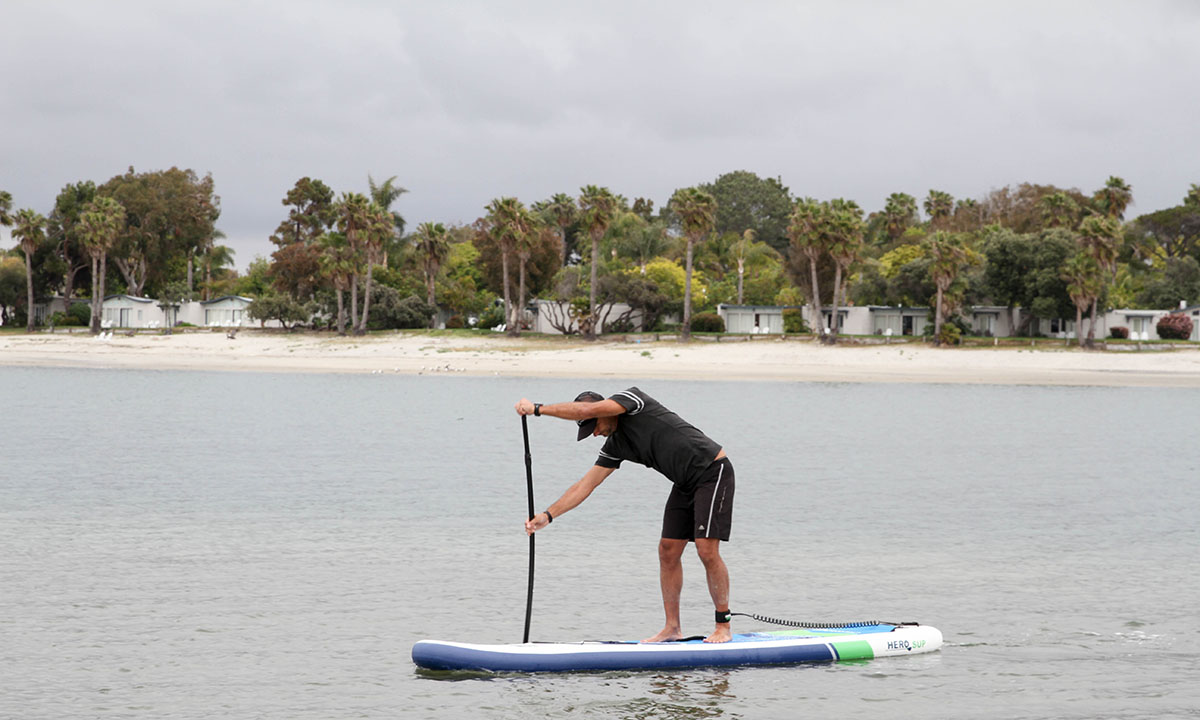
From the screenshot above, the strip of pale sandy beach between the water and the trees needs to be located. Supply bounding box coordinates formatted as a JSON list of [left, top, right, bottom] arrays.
[[0, 330, 1200, 388]]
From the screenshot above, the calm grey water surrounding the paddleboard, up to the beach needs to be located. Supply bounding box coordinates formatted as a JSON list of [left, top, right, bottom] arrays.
[[0, 367, 1200, 719]]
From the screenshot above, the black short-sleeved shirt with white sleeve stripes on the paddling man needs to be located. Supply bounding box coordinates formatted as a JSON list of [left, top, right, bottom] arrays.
[[596, 388, 721, 492]]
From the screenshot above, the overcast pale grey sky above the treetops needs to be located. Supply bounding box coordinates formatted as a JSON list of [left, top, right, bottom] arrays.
[[0, 0, 1200, 270]]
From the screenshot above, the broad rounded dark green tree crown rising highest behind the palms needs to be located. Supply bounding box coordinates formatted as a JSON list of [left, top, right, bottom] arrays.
[[700, 170, 792, 252]]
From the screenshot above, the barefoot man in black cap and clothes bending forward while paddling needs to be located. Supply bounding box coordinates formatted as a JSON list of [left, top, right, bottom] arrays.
[[516, 388, 733, 642]]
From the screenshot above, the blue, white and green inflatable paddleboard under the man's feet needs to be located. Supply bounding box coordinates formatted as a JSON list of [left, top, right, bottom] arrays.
[[413, 624, 942, 672]]
